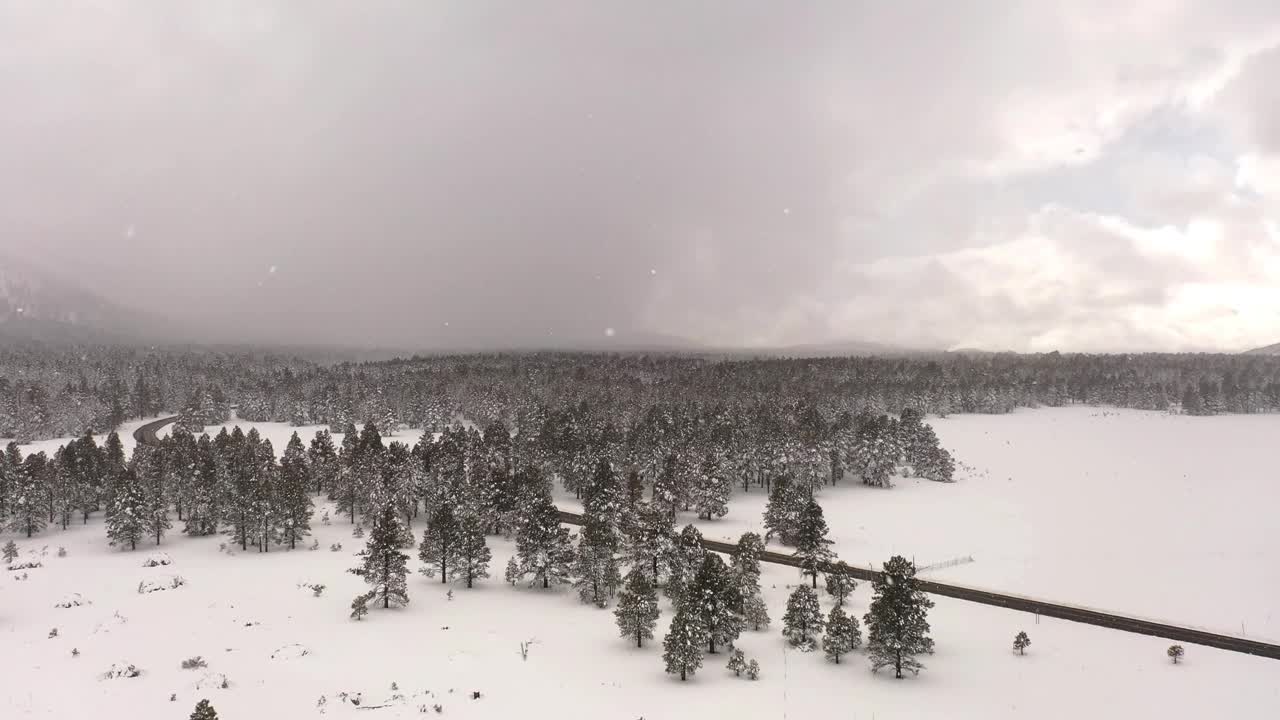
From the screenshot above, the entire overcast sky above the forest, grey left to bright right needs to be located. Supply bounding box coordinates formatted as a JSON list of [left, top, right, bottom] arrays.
[[0, 0, 1280, 351]]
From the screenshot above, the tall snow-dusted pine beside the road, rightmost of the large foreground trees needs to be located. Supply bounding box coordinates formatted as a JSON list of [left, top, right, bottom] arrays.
[[864, 555, 933, 678]]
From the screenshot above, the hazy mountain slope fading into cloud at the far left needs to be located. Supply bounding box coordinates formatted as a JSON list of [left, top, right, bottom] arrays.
[[0, 255, 160, 343]]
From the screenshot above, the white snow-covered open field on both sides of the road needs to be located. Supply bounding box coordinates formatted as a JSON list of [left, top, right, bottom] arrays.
[[0, 409, 1280, 720]]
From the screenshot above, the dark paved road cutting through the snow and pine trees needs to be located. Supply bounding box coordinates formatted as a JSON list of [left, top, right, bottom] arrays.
[[133, 416, 1280, 660]]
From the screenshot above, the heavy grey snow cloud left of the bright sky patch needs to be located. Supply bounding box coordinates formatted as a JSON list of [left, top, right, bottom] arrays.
[[0, 0, 1274, 347]]
